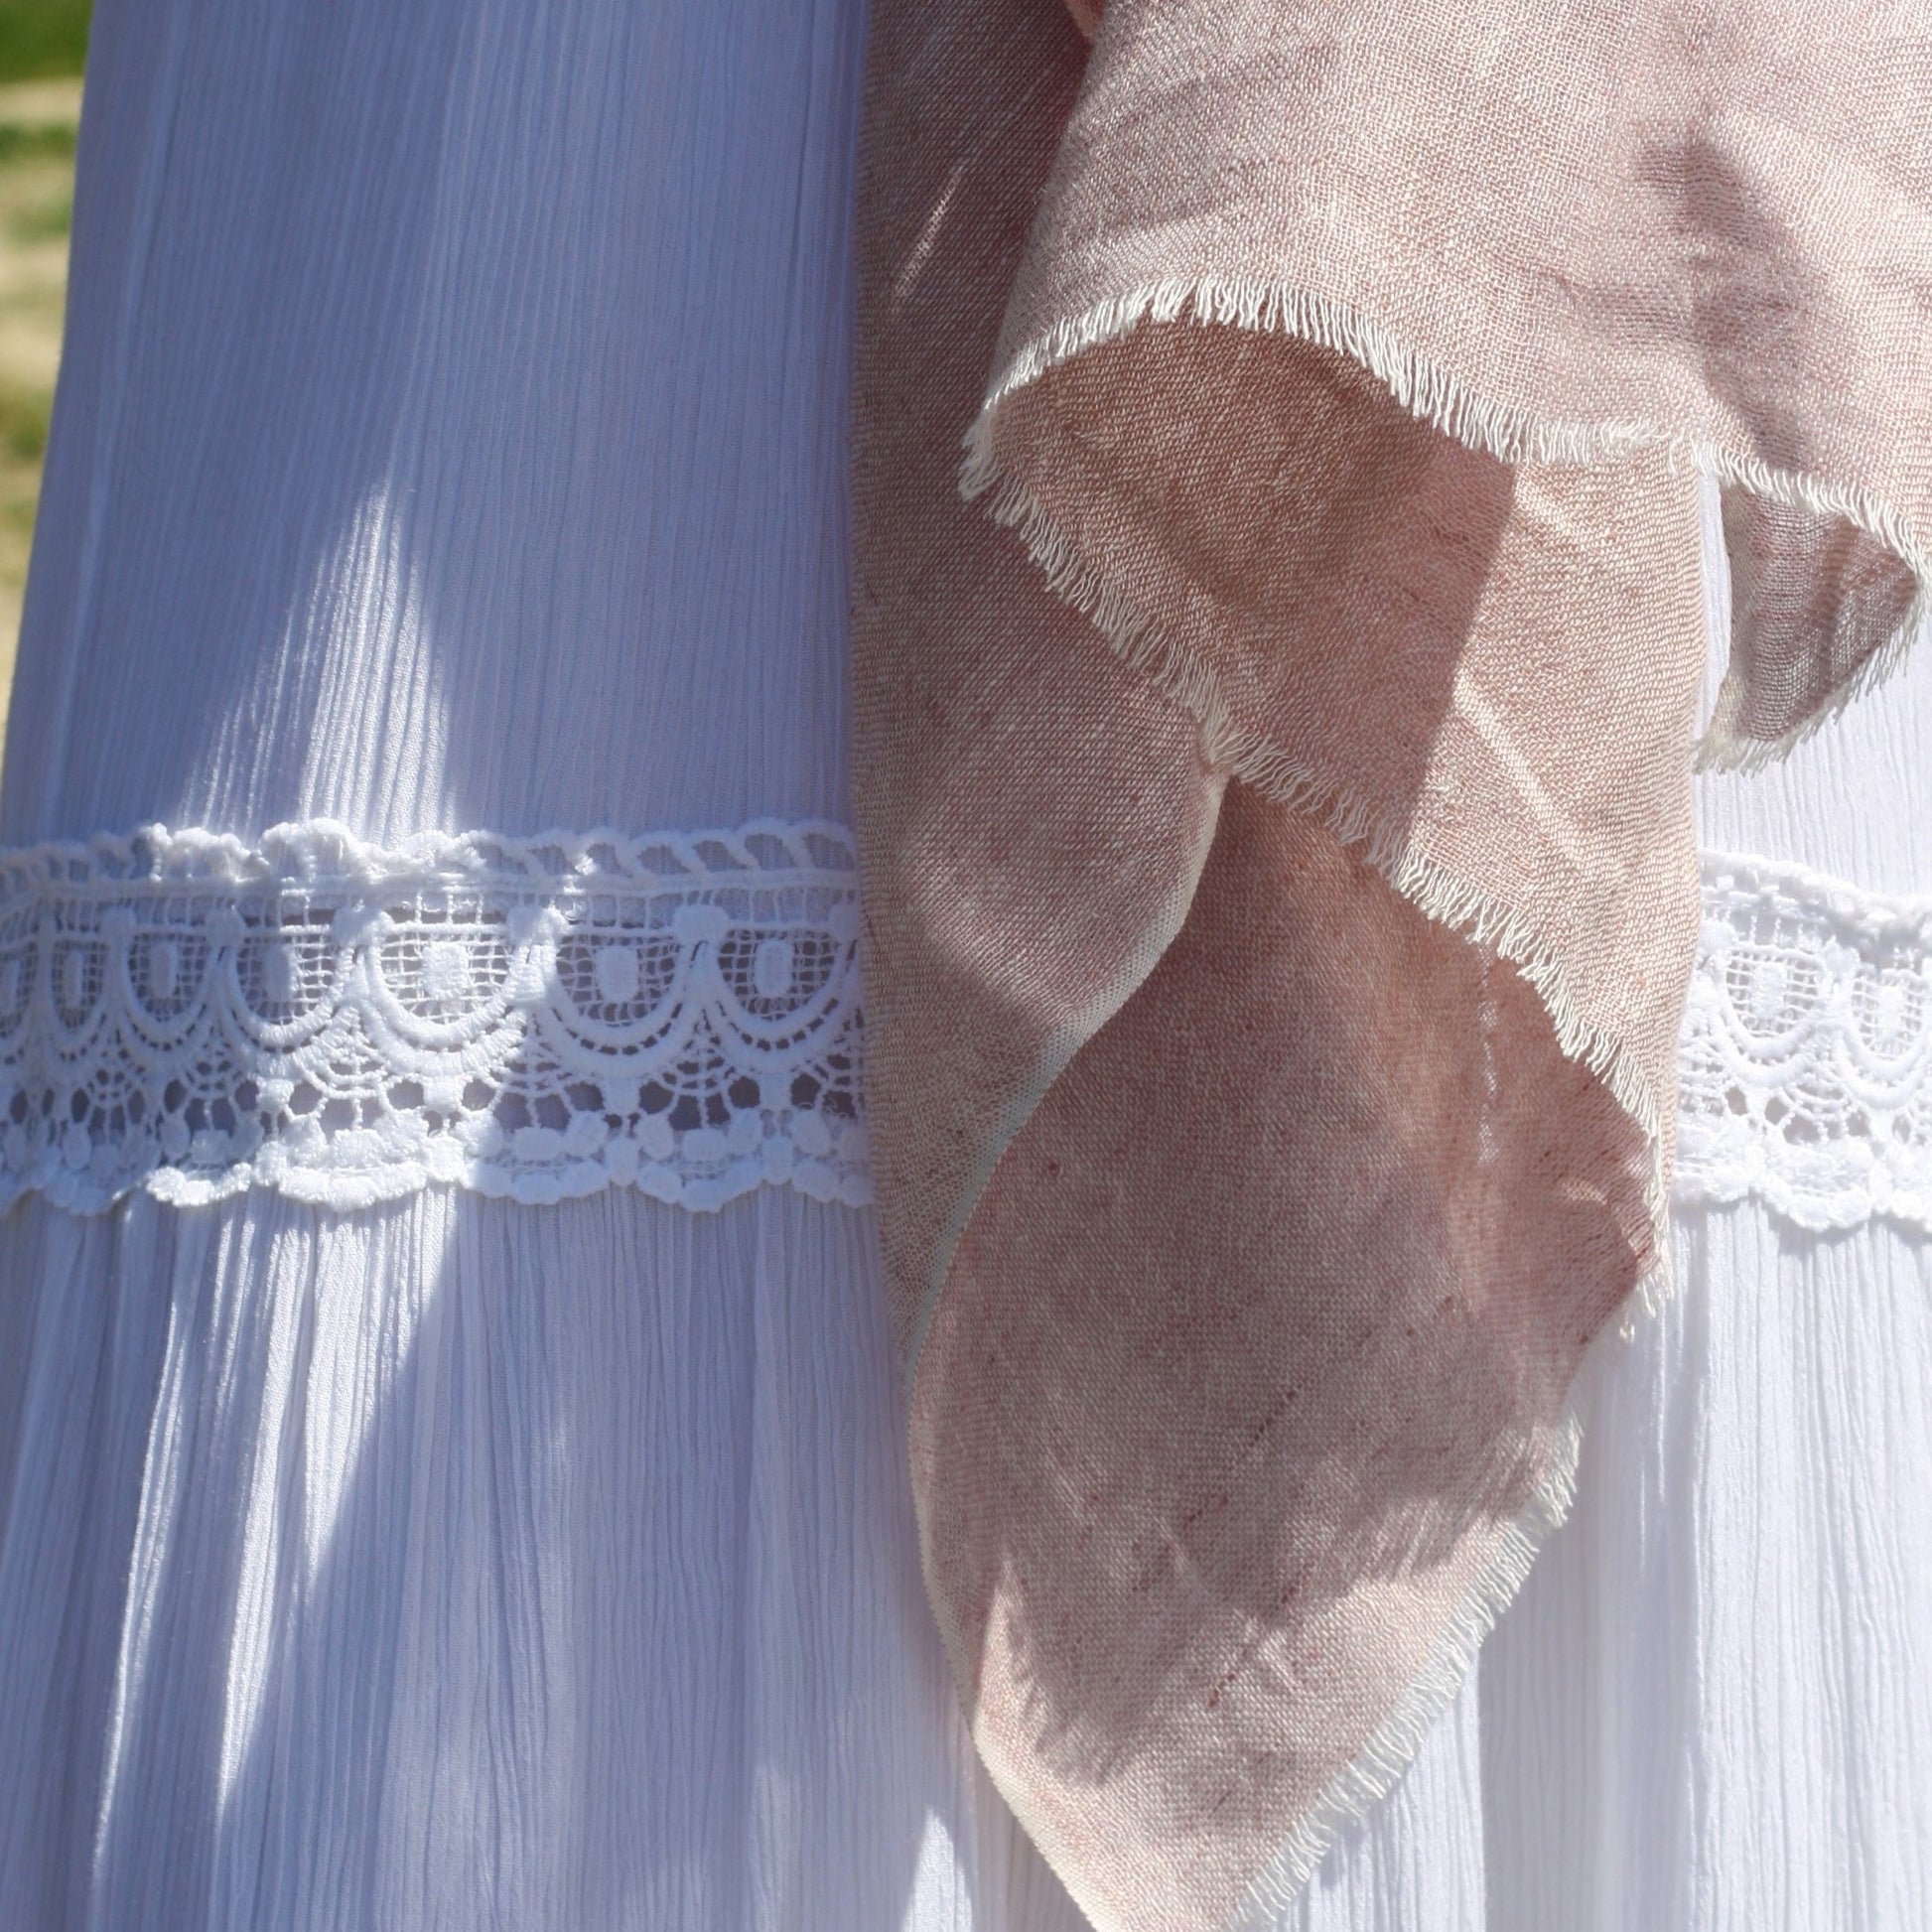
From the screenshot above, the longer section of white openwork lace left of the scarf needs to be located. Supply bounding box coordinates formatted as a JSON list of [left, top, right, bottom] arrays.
[[0, 821, 870, 1211]]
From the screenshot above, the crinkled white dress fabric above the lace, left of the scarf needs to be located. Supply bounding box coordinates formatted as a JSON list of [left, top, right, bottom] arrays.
[[0, 0, 864, 846]]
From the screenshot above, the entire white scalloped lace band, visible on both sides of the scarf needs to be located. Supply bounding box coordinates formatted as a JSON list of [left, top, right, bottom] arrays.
[[0, 821, 1932, 1229]]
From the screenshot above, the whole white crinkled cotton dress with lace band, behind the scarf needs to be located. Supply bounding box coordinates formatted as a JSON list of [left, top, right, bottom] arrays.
[[0, 0, 1932, 1932]]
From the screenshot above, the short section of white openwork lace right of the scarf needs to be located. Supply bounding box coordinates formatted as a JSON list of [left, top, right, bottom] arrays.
[[1675, 858, 1932, 1229]]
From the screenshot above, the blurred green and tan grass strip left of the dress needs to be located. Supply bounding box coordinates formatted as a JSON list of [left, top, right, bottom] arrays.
[[0, 0, 89, 764]]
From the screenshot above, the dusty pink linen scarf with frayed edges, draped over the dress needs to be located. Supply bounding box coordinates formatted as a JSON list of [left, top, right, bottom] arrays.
[[854, 0, 1932, 1928]]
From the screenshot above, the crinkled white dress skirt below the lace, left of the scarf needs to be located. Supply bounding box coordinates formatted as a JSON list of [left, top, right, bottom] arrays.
[[0, 1190, 1012, 1932]]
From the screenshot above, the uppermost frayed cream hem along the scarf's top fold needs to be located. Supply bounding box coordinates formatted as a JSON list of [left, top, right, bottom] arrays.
[[960, 276, 1932, 772]]
